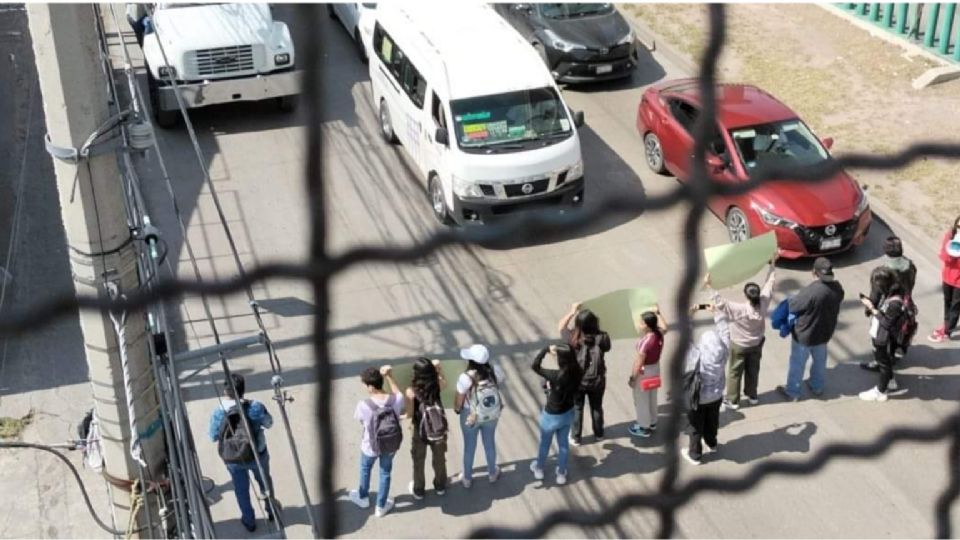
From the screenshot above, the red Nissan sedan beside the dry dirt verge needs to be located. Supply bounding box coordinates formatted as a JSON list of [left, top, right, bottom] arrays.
[[637, 79, 872, 259]]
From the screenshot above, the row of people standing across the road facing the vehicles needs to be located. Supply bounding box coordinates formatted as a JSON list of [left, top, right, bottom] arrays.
[[209, 217, 960, 531]]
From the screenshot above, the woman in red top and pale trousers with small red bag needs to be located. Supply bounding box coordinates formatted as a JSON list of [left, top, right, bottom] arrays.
[[627, 306, 667, 437]]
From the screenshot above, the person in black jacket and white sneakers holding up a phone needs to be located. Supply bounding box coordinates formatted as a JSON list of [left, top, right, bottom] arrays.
[[860, 268, 905, 401]]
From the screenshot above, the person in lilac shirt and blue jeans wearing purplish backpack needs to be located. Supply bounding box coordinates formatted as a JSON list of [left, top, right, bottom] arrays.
[[350, 366, 404, 517]]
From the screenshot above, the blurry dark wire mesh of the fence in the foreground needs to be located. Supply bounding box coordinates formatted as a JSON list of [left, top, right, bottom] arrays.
[[0, 4, 960, 538]]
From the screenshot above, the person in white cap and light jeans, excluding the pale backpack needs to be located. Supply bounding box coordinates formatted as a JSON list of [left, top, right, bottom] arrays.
[[453, 345, 504, 488]]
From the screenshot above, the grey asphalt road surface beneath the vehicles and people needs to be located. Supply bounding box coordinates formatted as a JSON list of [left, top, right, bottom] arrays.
[[9, 5, 960, 538]]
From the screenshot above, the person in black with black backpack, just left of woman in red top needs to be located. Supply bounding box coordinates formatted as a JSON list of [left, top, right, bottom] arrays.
[[559, 303, 610, 446]]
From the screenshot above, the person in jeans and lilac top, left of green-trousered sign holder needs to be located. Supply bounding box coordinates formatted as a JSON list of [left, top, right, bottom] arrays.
[[350, 366, 404, 517]]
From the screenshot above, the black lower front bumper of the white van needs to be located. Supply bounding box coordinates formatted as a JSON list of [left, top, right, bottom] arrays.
[[451, 177, 584, 225]]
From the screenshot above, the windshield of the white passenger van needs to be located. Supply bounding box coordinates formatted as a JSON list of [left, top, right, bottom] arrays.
[[450, 87, 573, 150]]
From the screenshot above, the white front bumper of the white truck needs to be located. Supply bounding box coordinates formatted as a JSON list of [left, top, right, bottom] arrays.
[[157, 69, 303, 111]]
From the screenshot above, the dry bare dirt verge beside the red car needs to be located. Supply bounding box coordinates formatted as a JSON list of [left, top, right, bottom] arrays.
[[621, 4, 960, 235]]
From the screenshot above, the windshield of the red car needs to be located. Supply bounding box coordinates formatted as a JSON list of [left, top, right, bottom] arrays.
[[730, 119, 830, 172]]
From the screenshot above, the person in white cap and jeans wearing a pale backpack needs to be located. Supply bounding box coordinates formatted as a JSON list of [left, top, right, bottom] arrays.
[[453, 344, 504, 488]]
